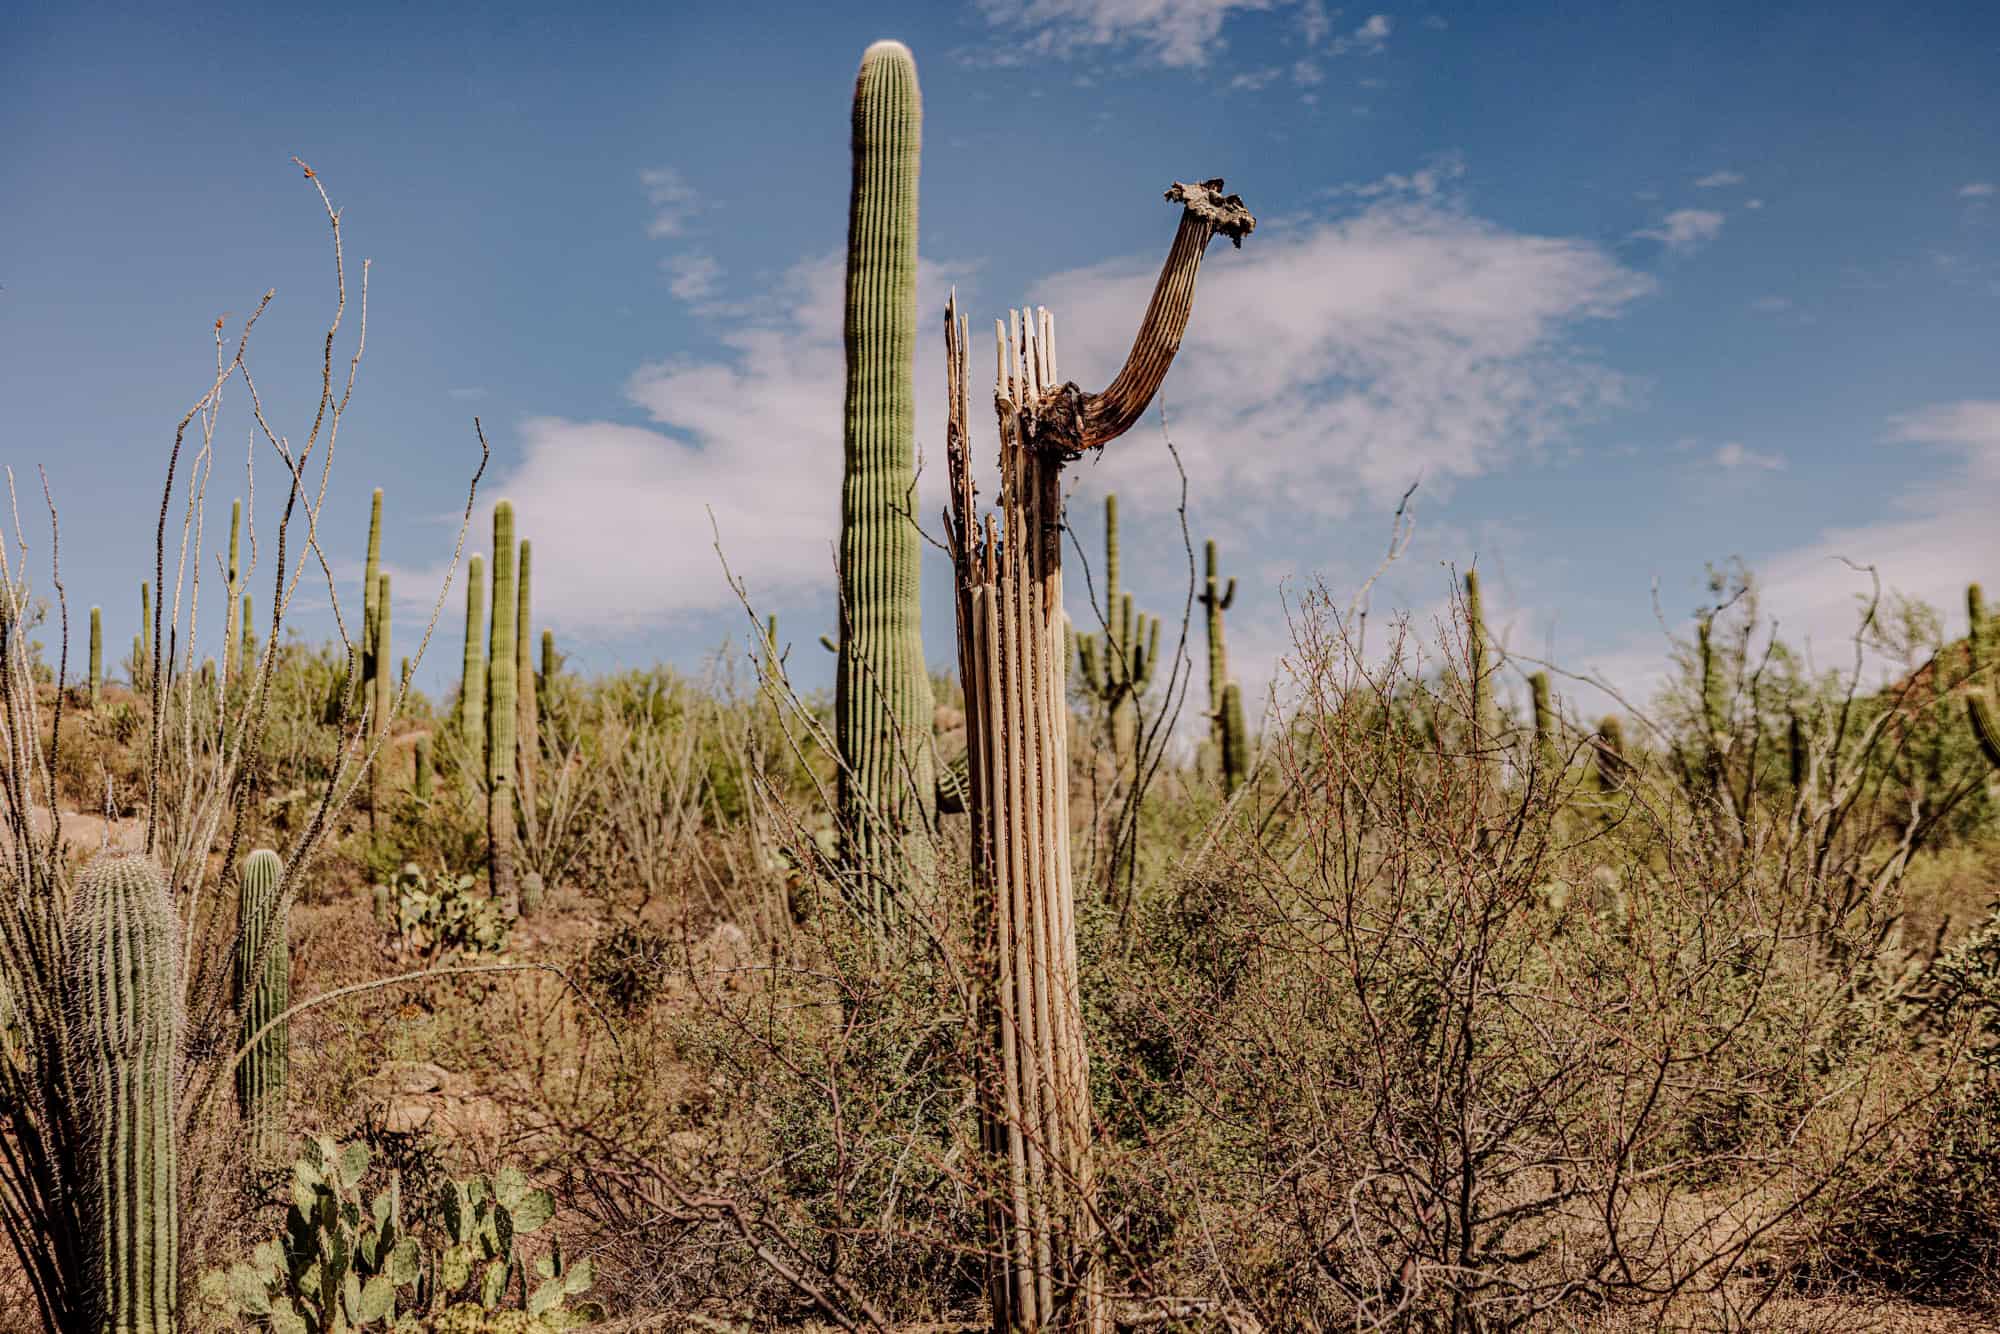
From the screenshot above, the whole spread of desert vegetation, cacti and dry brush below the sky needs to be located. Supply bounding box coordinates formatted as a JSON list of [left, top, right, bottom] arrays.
[[0, 42, 2000, 1334]]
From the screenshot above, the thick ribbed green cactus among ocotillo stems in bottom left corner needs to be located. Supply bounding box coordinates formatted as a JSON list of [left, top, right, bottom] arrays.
[[64, 856, 180, 1334]]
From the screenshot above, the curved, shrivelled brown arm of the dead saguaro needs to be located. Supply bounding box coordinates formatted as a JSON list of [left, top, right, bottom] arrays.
[[1020, 176, 1256, 460]]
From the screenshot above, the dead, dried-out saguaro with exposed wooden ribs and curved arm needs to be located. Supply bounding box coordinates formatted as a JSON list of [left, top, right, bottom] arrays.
[[944, 180, 1256, 1334]]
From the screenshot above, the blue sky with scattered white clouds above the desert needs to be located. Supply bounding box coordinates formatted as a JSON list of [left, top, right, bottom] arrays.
[[0, 0, 2000, 724]]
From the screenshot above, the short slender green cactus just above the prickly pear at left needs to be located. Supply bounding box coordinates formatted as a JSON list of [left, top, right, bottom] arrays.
[[236, 848, 292, 1166]]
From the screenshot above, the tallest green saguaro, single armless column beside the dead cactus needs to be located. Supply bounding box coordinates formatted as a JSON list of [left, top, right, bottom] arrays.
[[834, 42, 934, 908]]
